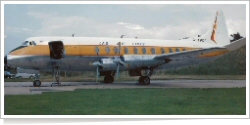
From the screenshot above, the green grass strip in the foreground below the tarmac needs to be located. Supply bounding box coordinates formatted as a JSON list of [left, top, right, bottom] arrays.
[[4, 88, 246, 115]]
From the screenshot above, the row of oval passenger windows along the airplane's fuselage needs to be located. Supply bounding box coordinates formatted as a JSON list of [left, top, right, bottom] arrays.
[[95, 47, 186, 54]]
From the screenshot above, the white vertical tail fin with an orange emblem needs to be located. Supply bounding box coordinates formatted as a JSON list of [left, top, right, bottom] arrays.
[[194, 10, 230, 46]]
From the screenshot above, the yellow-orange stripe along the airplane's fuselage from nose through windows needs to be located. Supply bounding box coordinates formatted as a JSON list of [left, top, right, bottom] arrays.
[[11, 45, 200, 56]]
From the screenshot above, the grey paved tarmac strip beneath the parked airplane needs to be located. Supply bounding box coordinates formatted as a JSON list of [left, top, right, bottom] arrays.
[[4, 80, 246, 95]]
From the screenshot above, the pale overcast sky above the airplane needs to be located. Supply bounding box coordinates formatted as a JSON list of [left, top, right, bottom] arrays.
[[1, 4, 246, 54]]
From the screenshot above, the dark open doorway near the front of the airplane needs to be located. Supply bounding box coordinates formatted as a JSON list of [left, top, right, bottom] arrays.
[[49, 41, 65, 59]]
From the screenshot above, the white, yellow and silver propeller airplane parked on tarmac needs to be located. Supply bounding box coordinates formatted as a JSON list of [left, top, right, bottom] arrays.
[[4, 10, 245, 87]]
